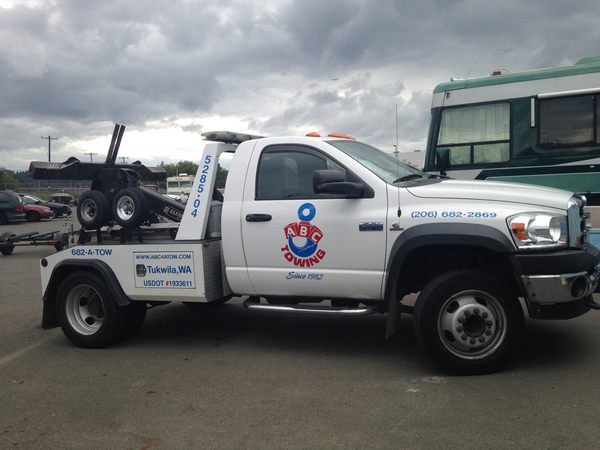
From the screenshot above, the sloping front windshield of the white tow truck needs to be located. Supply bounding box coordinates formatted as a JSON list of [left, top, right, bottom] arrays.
[[327, 139, 429, 184]]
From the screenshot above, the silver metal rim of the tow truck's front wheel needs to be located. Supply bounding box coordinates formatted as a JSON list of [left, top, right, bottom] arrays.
[[437, 290, 507, 360]]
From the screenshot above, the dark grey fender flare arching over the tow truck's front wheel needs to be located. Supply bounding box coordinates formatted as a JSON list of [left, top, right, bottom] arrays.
[[384, 223, 515, 337]]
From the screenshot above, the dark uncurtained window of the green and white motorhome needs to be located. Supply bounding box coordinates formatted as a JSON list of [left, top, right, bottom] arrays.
[[540, 95, 595, 147]]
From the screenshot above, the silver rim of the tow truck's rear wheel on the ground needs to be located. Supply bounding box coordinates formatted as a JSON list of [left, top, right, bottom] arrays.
[[66, 284, 104, 336]]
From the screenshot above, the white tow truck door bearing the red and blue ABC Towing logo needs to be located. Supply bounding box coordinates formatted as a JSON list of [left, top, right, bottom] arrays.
[[241, 144, 387, 299]]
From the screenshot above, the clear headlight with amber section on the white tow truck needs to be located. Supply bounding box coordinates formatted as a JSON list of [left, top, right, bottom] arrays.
[[507, 213, 568, 249]]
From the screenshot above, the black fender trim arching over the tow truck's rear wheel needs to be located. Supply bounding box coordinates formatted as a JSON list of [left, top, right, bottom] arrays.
[[42, 259, 131, 329]]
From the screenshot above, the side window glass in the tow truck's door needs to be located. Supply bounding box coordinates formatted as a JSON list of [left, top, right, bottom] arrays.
[[256, 150, 346, 200]]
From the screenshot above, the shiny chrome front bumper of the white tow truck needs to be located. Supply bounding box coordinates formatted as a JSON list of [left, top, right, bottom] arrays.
[[521, 270, 600, 304]]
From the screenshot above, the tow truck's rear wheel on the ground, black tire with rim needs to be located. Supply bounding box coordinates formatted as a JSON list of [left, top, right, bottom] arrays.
[[56, 271, 128, 348]]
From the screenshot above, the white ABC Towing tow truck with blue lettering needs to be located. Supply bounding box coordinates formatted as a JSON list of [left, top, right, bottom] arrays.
[[41, 133, 600, 374]]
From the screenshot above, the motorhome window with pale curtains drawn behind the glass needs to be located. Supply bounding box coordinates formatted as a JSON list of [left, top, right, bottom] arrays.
[[437, 103, 510, 165]]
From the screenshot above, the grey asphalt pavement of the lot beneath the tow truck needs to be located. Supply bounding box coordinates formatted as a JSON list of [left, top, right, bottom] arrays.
[[0, 219, 600, 449]]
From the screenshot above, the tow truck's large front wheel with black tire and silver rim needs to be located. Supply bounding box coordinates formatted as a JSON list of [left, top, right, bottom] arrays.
[[413, 270, 523, 375]]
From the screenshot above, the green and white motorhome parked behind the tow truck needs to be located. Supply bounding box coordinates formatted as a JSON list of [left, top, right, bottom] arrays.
[[424, 57, 600, 209]]
